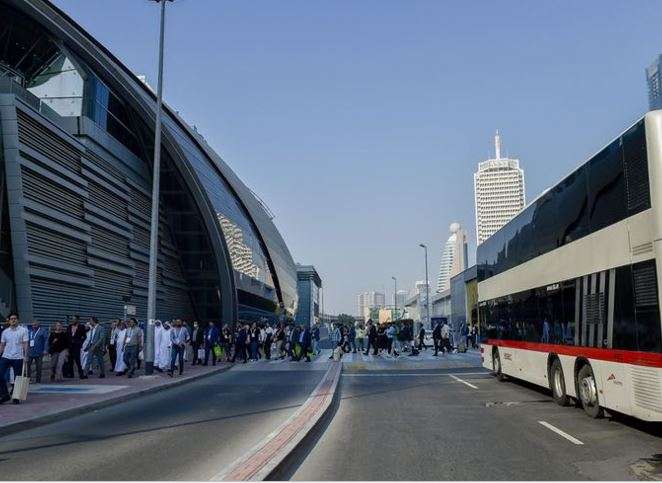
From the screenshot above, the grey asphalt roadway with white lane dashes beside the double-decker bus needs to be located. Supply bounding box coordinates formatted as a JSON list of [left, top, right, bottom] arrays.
[[291, 368, 662, 480]]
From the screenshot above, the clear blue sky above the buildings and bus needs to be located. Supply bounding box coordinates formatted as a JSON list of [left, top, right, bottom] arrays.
[[54, 0, 662, 314]]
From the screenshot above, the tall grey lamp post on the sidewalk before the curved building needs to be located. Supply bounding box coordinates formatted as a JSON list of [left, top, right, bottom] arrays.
[[145, 0, 173, 374]]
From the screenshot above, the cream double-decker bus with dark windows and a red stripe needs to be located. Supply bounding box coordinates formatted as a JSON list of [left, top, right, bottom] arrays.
[[477, 111, 662, 421]]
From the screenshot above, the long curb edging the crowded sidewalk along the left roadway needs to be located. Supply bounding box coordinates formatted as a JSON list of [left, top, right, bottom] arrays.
[[0, 365, 233, 436]]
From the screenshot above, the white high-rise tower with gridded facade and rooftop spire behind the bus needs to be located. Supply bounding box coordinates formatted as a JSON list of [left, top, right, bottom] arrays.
[[474, 131, 526, 245]]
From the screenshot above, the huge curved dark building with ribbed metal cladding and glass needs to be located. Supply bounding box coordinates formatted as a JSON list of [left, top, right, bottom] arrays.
[[0, 0, 297, 324]]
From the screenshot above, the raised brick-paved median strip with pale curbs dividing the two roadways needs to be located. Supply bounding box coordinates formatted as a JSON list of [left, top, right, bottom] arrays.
[[211, 362, 342, 481]]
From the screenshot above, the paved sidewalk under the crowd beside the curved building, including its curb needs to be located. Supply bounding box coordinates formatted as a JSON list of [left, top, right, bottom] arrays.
[[0, 363, 233, 436]]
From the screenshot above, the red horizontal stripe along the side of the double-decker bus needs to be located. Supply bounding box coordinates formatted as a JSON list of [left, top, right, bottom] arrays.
[[487, 339, 662, 367]]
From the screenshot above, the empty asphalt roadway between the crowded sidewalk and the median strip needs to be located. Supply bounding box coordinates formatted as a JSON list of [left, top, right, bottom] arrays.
[[0, 364, 326, 480]]
